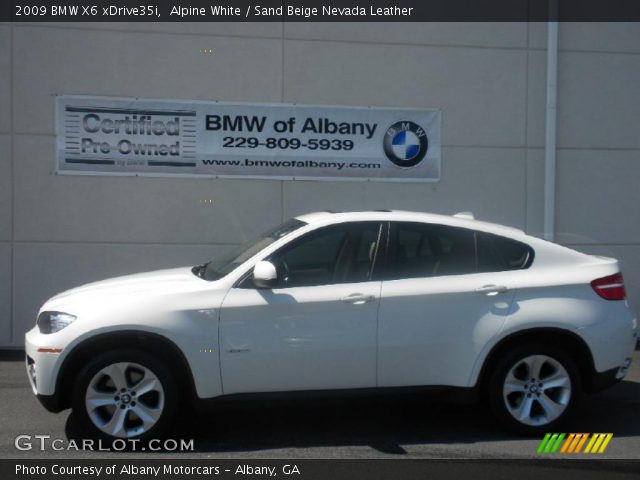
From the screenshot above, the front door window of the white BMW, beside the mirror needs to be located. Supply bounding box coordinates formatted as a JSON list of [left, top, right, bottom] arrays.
[[268, 222, 381, 288]]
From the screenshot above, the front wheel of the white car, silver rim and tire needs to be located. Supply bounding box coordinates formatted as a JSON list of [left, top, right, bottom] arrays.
[[73, 350, 178, 440]]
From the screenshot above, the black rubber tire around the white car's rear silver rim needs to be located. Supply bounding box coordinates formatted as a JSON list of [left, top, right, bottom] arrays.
[[487, 343, 582, 436]]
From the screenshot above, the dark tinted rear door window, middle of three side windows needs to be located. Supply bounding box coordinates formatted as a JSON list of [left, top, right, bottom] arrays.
[[384, 222, 476, 280]]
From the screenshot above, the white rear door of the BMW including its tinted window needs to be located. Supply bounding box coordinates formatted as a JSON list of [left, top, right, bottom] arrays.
[[378, 222, 514, 387]]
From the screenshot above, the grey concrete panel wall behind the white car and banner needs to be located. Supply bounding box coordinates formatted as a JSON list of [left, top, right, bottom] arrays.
[[0, 23, 640, 346]]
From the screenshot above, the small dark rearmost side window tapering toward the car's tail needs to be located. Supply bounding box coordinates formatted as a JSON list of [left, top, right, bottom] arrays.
[[476, 232, 533, 272]]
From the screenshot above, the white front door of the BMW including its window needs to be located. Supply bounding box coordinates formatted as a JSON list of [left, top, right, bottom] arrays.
[[220, 222, 382, 394]]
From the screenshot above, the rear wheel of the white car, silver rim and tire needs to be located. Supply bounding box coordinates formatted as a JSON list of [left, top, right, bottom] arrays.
[[488, 344, 581, 435]]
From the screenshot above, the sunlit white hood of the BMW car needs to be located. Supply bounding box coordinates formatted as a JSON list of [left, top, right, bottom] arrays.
[[41, 267, 215, 315]]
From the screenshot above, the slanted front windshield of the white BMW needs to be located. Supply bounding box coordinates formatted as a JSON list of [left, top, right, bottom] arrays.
[[191, 218, 306, 281]]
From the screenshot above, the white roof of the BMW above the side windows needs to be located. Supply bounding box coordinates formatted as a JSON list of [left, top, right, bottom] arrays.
[[295, 210, 526, 237]]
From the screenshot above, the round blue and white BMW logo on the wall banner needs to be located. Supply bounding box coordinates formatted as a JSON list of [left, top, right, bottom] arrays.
[[383, 120, 429, 167]]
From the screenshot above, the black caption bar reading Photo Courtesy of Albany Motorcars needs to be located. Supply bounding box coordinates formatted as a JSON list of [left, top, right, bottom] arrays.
[[0, 457, 640, 480]]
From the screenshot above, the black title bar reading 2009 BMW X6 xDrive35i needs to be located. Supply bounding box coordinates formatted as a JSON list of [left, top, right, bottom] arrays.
[[0, 0, 640, 22]]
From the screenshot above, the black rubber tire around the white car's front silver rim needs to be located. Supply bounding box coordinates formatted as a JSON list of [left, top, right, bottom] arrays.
[[72, 349, 179, 443]]
